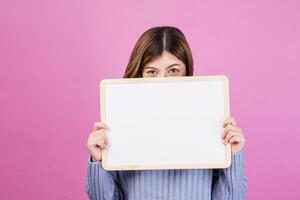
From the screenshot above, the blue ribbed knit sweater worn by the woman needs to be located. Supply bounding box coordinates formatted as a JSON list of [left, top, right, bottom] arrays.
[[85, 151, 247, 200]]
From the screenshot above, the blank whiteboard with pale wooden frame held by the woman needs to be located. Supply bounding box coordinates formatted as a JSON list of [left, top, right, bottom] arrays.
[[100, 75, 231, 170]]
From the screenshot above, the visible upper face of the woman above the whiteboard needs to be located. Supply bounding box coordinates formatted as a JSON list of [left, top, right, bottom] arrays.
[[142, 51, 186, 78]]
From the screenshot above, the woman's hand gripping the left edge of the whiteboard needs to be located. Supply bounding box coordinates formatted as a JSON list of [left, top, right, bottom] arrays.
[[87, 122, 110, 162]]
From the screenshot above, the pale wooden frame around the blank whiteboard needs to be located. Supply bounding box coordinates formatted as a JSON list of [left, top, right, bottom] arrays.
[[100, 75, 231, 170]]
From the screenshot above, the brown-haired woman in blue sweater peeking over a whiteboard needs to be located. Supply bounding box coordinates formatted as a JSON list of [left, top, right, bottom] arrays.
[[85, 26, 246, 200]]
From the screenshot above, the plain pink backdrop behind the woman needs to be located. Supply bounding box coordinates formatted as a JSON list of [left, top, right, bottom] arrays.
[[0, 0, 300, 200]]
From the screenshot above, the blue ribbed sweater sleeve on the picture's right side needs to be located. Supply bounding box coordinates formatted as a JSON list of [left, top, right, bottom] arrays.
[[212, 150, 247, 200]]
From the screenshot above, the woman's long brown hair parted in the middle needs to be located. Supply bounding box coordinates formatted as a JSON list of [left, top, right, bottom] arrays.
[[123, 26, 194, 78]]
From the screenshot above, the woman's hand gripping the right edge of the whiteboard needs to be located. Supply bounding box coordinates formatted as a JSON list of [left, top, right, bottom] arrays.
[[222, 117, 246, 153]]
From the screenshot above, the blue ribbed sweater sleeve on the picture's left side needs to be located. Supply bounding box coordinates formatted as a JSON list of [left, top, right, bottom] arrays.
[[85, 156, 124, 200]]
